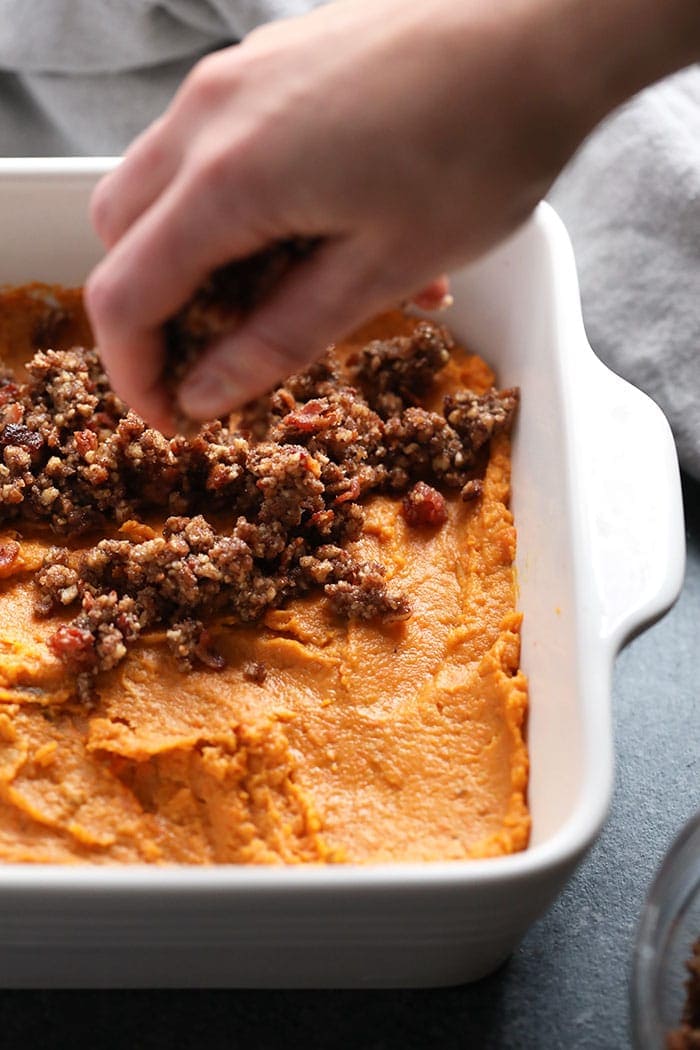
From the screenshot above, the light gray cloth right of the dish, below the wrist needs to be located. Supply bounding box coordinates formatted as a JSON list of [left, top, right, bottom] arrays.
[[550, 65, 700, 479]]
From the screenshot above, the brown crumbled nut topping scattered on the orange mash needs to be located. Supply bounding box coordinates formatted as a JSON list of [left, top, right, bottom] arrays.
[[0, 322, 517, 698]]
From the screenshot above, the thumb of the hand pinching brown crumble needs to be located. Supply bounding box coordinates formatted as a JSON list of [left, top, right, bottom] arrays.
[[178, 240, 401, 420]]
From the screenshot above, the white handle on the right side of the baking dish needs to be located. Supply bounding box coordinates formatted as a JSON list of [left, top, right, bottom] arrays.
[[582, 348, 685, 651]]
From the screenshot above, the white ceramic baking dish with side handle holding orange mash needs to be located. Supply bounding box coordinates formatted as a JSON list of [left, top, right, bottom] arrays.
[[0, 160, 684, 987]]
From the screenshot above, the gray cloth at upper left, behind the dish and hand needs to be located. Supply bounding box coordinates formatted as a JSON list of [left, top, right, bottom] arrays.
[[0, 0, 323, 156]]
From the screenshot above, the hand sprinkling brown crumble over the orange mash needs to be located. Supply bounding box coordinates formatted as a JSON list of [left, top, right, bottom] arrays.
[[86, 0, 700, 431]]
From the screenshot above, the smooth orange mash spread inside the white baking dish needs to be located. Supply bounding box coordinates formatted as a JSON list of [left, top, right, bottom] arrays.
[[0, 293, 530, 863]]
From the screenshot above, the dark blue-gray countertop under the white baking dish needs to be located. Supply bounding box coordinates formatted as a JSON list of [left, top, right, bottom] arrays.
[[0, 482, 700, 1050]]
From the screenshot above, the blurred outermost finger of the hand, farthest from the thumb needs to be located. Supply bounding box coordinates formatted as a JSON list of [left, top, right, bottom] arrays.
[[90, 118, 182, 248]]
